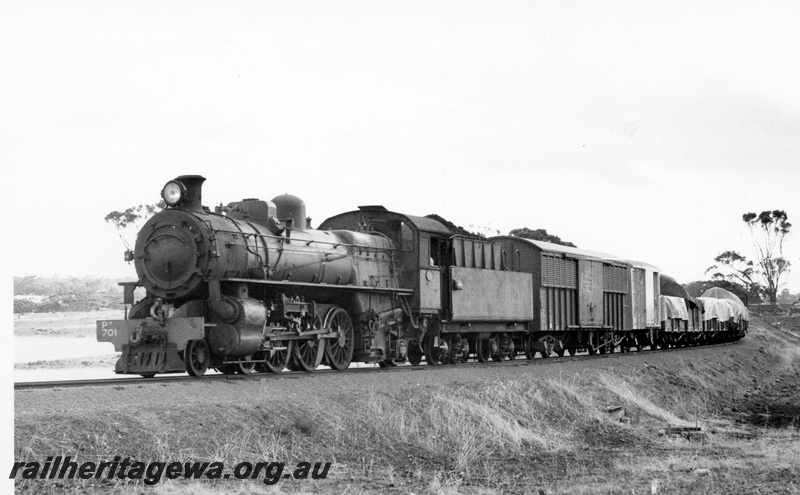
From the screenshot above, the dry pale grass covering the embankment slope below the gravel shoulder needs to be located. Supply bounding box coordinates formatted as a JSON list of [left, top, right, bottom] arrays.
[[15, 320, 800, 494]]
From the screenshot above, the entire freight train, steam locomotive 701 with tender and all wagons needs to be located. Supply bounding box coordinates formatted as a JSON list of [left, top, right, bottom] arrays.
[[97, 175, 747, 377]]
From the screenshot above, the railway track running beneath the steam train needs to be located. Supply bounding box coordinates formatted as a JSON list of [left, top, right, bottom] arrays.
[[14, 341, 740, 390]]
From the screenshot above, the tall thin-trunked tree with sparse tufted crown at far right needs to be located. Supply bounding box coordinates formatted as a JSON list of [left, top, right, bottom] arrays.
[[742, 210, 792, 307]]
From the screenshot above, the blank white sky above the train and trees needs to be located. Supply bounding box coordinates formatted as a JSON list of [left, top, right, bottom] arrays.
[[0, 0, 800, 292]]
